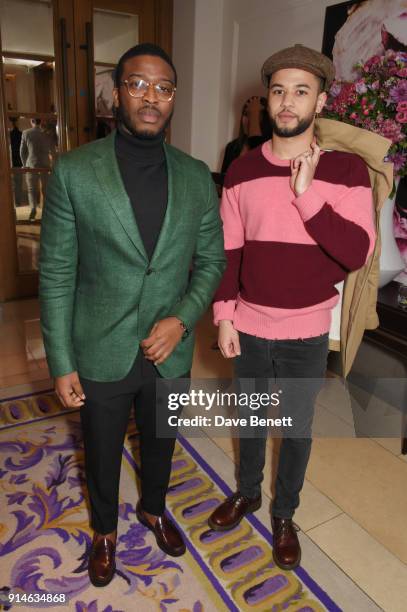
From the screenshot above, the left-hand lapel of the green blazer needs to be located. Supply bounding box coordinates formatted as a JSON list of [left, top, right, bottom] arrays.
[[92, 131, 149, 261]]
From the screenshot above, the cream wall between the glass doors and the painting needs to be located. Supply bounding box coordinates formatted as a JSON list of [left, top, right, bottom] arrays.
[[172, 0, 338, 170]]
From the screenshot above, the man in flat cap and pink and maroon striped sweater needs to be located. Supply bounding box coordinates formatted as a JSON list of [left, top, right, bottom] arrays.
[[209, 45, 375, 569]]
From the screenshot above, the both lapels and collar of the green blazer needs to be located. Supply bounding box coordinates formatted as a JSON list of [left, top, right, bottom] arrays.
[[92, 131, 185, 264]]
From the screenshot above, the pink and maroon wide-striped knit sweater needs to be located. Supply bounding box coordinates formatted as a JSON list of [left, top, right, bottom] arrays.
[[213, 141, 375, 339]]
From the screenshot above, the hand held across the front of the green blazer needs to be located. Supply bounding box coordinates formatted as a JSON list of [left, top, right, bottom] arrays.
[[140, 317, 184, 365]]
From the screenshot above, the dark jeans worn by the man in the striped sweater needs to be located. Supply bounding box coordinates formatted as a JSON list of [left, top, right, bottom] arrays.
[[235, 332, 328, 518]]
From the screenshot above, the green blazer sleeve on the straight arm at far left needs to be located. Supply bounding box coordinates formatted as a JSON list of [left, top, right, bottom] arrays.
[[39, 162, 78, 376]]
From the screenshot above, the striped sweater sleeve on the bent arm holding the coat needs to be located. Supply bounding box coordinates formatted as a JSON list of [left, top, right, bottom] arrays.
[[293, 155, 376, 272]]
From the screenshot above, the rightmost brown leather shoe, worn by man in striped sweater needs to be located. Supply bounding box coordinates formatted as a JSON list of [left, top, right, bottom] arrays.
[[271, 517, 301, 570]]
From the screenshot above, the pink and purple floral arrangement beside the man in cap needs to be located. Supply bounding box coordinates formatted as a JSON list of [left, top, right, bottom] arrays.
[[324, 49, 407, 176]]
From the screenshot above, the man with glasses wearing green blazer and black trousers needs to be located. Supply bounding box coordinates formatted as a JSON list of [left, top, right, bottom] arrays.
[[40, 43, 225, 586]]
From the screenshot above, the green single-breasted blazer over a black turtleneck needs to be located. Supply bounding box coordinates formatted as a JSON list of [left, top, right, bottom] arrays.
[[40, 133, 226, 382]]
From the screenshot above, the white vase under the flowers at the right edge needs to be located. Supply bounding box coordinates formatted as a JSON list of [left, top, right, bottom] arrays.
[[379, 178, 405, 287]]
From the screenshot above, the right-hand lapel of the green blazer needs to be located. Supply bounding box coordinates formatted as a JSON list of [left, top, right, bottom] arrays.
[[151, 144, 186, 263]]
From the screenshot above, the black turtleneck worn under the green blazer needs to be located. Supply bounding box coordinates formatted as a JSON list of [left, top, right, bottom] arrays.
[[115, 126, 168, 259]]
